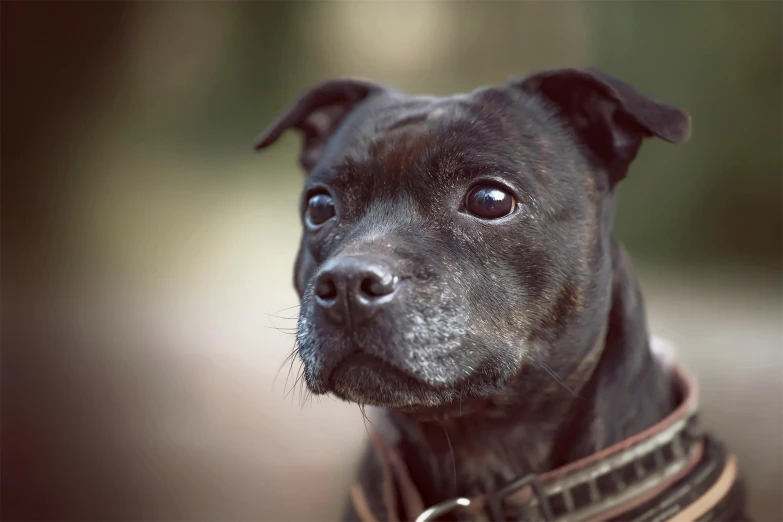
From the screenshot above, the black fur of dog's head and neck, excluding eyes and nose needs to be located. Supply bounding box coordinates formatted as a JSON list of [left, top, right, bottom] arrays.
[[258, 69, 712, 518]]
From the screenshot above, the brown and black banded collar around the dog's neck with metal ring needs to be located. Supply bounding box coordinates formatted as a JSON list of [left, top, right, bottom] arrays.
[[351, 364, 744, 522]]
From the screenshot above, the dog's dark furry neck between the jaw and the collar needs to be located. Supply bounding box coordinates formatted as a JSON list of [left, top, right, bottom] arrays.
[[380, 244, 675, 503]]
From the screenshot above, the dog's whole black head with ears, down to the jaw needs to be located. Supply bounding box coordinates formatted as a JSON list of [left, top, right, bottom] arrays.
[[258, 70, 689, 411]]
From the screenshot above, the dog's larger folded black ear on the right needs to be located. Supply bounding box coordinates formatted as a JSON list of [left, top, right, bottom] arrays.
[[514, 69, 691, 183]]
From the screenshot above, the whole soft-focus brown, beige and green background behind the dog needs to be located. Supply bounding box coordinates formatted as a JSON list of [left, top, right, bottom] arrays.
[[2, 2, 783, 520]]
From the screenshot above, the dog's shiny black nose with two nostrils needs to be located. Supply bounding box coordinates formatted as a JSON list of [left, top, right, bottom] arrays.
[[315, 255, 399, 324]]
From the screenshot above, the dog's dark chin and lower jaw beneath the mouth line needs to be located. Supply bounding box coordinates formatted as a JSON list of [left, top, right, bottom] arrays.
[[327, 353, 455, 411]]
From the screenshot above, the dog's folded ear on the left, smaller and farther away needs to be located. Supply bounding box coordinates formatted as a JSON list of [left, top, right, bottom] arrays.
[[254, 79, 383, 171]]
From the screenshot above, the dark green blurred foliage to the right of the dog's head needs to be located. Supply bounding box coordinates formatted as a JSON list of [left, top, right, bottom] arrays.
[[590, 2, 783, 271]]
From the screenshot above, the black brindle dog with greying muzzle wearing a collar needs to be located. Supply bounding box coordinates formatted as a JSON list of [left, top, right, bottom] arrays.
[[255, 69, 747, 521]]
